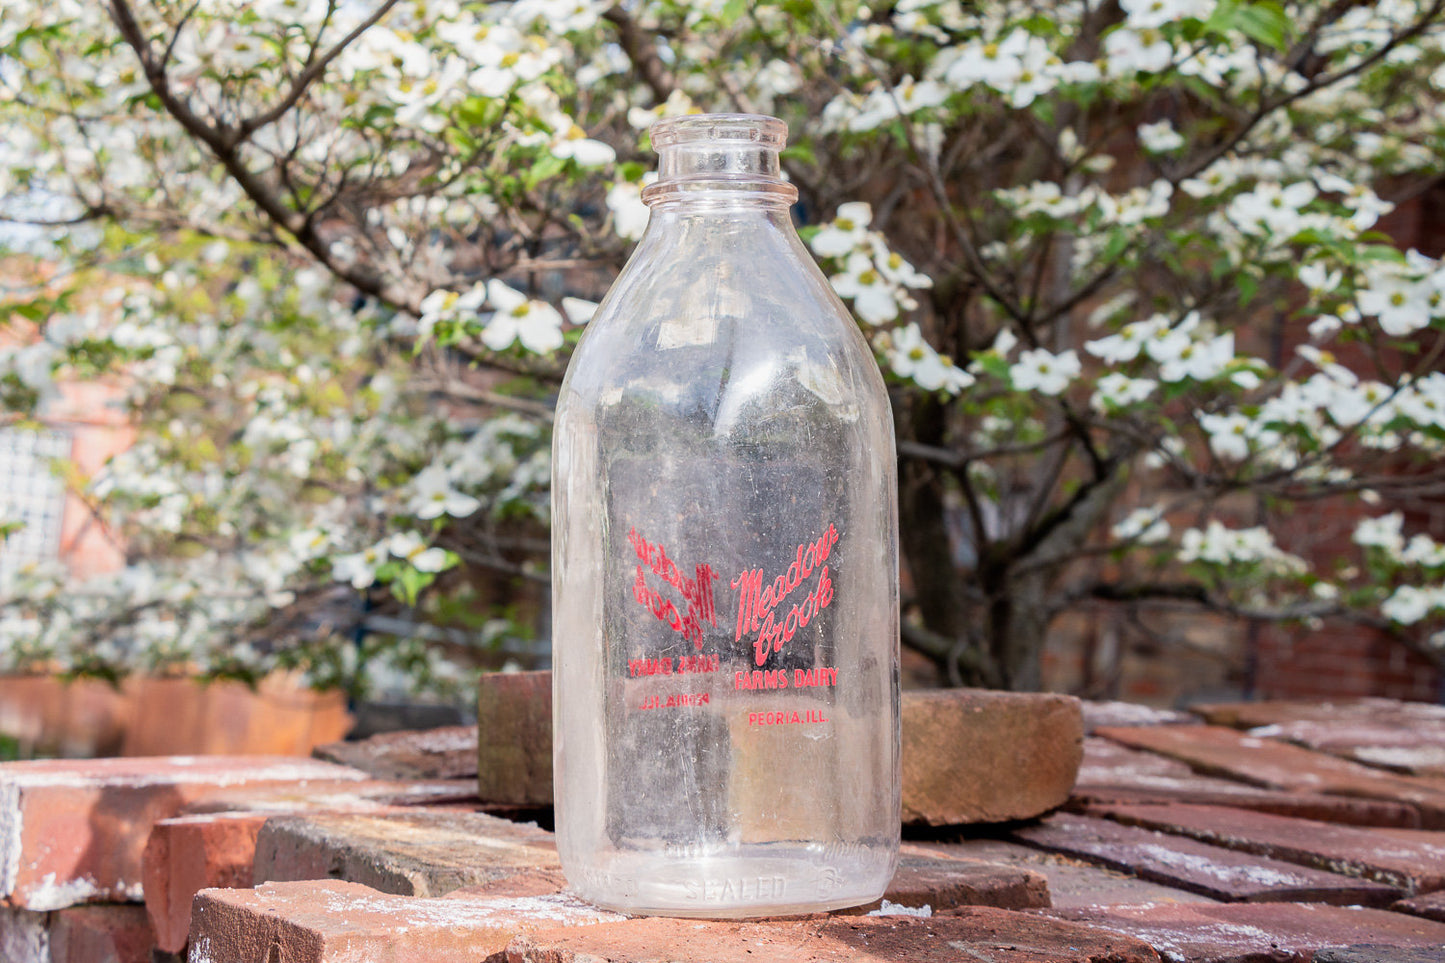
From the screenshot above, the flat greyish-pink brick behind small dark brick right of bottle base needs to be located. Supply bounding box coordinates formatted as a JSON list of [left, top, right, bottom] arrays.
[[890, 839, 1209, 907]]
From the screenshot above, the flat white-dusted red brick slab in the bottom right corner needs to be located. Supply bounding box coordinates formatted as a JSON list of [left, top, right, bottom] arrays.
[[1048, 902, 1445, 963]]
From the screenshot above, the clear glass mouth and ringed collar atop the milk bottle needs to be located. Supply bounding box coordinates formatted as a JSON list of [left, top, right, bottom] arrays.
[[642, 114, 798, 205]]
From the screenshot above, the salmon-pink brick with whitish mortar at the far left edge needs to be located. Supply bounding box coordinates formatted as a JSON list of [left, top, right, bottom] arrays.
[[0, 756, 364, 910]]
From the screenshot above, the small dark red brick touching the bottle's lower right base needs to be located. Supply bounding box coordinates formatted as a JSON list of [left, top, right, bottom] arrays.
[[847, 844, 1051, 915]]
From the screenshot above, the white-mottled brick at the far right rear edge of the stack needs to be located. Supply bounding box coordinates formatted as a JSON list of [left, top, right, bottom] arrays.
[[1194, 698, 1445, 776]]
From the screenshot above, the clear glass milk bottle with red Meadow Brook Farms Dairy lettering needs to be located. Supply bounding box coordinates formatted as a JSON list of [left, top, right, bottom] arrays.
[[552, 114, 899, 917]]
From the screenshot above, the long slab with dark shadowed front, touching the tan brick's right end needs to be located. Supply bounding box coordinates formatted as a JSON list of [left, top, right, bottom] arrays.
[[1069, 737, 1420, 829]]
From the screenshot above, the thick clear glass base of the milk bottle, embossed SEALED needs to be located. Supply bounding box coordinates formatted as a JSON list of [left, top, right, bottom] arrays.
[[564, 843, 896, 920]]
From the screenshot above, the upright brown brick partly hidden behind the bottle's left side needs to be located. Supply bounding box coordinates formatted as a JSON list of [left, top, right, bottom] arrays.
[[477, 672, 552, 807]]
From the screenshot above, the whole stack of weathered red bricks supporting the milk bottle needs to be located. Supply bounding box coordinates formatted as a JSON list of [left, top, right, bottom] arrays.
[[0, 677, 1445, 963]]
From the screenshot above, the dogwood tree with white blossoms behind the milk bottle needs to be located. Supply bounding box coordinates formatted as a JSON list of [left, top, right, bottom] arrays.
[[0, 0, 1445, 687]]
